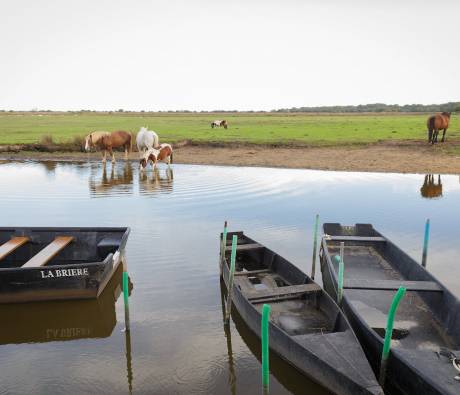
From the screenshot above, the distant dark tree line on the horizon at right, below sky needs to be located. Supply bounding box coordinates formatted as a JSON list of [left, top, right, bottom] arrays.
[[272, 102, 460, 113]]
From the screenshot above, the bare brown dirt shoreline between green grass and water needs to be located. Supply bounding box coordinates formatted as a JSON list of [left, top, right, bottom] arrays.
[[0, 141, 460, 174]]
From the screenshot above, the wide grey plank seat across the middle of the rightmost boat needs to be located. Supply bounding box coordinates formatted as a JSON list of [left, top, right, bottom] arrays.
[[343, 279, 443, 292]]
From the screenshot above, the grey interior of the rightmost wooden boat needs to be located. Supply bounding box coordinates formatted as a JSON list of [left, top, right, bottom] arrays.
[[324, 224, 460, 351]]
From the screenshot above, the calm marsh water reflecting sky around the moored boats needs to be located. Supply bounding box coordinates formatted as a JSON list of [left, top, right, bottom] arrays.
[[0, 161, 460, 394]]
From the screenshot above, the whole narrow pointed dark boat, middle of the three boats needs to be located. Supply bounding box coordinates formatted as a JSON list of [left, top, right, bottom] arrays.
[[221, 232, 383, 395]]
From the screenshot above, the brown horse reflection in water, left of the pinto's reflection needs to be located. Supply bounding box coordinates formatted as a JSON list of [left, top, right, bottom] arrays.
[[89, 162, 133, 196]]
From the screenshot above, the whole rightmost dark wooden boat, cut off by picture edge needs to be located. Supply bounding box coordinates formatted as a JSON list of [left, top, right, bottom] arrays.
[[320, 224, 460, 395]]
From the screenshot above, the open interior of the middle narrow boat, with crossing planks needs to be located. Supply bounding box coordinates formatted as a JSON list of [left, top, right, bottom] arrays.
[[226, 232, 347, 336]]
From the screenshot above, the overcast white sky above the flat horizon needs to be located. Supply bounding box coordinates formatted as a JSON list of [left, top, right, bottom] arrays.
[[0, 0, 460, 110]]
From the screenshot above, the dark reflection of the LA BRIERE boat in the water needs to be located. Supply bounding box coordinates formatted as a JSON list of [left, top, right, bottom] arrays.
[[0, 265, 133, 345]]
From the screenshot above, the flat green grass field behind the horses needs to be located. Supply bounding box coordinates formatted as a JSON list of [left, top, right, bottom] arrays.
[[0, 113, 460, 145]]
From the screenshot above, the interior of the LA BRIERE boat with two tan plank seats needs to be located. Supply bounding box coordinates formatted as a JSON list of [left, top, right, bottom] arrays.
[[0, 227, 127, 269]]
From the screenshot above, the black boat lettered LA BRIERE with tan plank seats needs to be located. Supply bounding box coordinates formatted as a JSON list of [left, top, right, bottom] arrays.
[[0, 227, 129, 303]]
